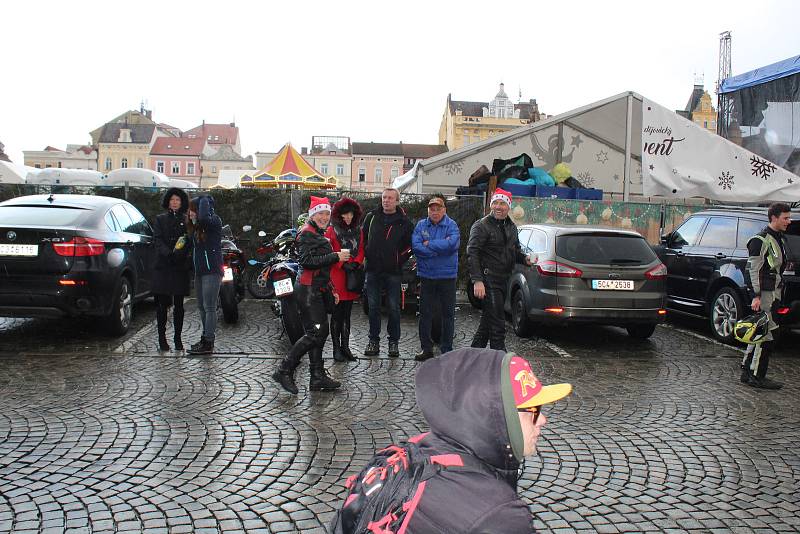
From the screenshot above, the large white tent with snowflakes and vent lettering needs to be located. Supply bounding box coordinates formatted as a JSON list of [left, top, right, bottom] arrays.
[[410, 92, 800, 202]]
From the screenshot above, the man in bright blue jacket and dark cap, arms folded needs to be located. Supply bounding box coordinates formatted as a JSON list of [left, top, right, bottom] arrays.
[[411, 195, 461, 362]]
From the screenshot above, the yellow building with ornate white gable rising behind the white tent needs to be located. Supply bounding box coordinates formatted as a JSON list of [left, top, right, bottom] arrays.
[[439, 83, 543, 150]]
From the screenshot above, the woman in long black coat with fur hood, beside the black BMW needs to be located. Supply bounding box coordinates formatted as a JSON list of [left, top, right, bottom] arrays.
[[151, 187, 192, 352]]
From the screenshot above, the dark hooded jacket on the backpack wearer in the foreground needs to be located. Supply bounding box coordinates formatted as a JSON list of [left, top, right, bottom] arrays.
[[407, 348, 534, 534]]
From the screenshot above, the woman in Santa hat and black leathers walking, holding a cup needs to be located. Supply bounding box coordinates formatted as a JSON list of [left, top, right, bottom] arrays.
[[272, 197, 350, 395]]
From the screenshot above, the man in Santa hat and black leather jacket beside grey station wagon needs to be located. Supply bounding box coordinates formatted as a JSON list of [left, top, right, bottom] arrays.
[[467, 187, 531, 351]]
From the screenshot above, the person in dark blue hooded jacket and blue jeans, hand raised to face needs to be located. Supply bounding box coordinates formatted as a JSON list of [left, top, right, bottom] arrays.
[[189, 195, 224, 354]]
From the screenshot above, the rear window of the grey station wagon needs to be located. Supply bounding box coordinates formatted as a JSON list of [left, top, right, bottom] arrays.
[[556, 234, 656, 265]]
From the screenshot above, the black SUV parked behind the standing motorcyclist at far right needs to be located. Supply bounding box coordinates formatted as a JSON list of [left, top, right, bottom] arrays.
[[655, 208, 800, 342]]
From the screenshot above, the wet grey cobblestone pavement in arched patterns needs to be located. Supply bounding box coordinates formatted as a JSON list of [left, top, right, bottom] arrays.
[[0, 301, 800, 533]]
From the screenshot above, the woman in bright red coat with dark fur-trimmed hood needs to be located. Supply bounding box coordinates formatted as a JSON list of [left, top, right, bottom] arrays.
[[325, 197, 364, 362]]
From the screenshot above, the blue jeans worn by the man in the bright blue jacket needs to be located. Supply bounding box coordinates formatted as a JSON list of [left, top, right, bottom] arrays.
[[419, 278, 456, 354]]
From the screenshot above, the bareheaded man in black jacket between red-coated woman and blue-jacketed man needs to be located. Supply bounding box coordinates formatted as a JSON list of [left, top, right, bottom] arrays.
[[362, 188, 414, 358]]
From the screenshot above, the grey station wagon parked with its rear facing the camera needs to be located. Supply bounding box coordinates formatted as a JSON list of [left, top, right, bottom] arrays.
[[506, 224, 667, 339]]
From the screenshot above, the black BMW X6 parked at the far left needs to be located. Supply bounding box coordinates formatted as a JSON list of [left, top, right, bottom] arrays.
[[0, 195, 154, 335]]
